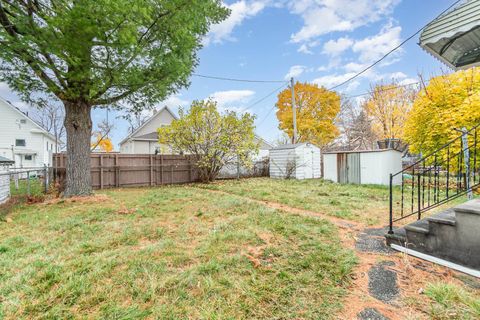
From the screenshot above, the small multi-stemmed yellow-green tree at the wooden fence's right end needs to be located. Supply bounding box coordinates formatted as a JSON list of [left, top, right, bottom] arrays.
[[158, 100, 258, 182]]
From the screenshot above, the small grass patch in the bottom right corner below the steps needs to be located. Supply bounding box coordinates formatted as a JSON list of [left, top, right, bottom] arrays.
[[425, 282, 480, 320]]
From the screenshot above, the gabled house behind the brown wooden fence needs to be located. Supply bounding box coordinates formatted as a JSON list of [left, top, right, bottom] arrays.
[[120, 106, 178, 154]]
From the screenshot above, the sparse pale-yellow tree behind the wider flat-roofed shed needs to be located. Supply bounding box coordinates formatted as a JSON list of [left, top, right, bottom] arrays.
[[363, 82, 416, 139]]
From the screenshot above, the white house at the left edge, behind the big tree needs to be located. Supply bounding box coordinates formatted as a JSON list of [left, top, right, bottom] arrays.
[[0, 98, 56, 167]]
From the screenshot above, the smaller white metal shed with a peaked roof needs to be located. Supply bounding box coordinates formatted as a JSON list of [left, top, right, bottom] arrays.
[[270, 143, 321, 179]]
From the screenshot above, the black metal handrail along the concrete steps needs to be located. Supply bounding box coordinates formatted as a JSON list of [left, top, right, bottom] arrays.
[[389, 124, 480, 234]]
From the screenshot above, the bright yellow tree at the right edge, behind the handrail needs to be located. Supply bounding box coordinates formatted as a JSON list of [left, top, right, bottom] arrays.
[[405, 68, 480, 158]]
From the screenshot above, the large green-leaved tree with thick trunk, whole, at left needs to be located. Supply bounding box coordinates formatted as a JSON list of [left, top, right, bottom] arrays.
[[0, 0, 228, 196]]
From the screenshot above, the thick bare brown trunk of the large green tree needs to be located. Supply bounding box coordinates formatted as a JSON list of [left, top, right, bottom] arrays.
[[64, 101, 92, 197]]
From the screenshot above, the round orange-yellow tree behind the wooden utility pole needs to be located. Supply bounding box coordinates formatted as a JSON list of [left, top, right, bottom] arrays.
[[276, 82, 340, 147]]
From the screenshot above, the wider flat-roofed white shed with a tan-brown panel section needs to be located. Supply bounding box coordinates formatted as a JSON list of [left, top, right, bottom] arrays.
[[323, 149, 403, 185]]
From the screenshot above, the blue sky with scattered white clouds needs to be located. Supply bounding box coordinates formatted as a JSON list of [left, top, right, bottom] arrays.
[[0, 0, 454, 149]]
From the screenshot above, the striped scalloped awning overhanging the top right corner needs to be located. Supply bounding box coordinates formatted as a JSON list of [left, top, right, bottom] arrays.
[[419, 0, 480, 70]]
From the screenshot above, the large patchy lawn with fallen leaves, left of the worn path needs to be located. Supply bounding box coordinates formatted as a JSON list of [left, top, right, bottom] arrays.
[[0, 186, 356, 319]]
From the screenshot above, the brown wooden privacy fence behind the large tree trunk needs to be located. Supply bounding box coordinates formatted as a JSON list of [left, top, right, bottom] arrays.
[[53, 153, 198, 189]]
